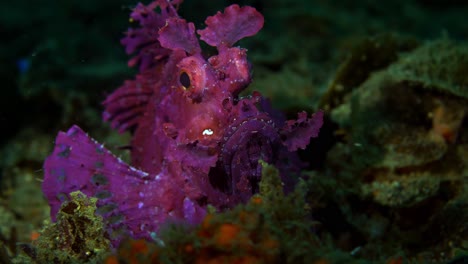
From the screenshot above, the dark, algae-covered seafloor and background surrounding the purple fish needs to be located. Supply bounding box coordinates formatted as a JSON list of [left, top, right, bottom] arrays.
[[0, 0, 468, 264]]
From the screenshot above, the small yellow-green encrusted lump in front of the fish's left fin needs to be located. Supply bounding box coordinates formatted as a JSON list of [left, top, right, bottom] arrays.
[[32, 191, 110, 263]]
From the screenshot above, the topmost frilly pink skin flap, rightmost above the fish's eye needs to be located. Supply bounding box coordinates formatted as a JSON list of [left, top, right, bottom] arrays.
[[197, 5, 264, 48]]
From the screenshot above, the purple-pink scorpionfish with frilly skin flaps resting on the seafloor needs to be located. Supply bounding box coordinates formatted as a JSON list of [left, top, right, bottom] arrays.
[[43, 0, 323, 245]]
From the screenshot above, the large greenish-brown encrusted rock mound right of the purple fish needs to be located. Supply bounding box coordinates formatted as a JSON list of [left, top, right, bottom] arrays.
[[330, 39, 468, 194]]
